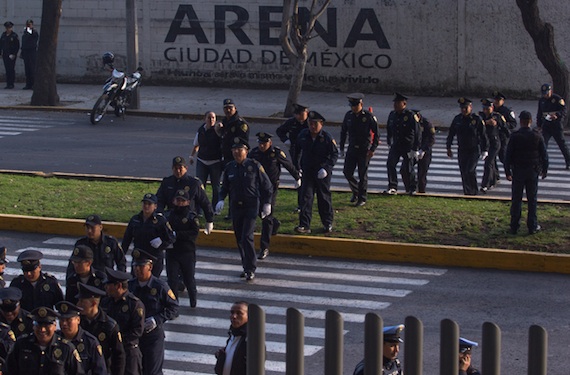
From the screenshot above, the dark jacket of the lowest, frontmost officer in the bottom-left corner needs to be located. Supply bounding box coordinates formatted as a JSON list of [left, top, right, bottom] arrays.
[[6, 332, 85, 375]]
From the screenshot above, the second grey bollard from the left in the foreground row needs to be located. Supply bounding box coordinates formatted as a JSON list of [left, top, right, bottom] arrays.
[[285, 307, 305, 375]]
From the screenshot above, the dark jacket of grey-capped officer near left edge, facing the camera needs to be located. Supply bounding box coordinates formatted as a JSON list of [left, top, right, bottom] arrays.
[[10, 272, 63, 311]]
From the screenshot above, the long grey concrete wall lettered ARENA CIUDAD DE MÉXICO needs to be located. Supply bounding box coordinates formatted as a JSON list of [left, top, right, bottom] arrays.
[[4, 0, 570, 97]]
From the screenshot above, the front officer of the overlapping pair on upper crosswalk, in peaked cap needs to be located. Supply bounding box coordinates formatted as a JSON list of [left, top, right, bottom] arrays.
[[386, 93, 421, 195]]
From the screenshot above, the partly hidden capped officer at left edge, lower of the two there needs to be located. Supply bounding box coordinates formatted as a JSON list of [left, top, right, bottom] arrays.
[[0, 287, 33, 337]]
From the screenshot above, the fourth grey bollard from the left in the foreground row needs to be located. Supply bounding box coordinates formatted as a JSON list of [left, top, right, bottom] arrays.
[[364, 313, 384, 375]]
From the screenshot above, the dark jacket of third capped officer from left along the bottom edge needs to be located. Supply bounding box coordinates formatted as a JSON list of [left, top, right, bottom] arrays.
[[81, 310, 125, 375]]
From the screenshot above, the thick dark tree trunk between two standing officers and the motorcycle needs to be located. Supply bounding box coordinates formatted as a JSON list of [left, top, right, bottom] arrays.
[[31, 0, 62, 106]]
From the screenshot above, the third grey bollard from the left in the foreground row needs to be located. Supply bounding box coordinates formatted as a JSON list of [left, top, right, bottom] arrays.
[[324, 310, 344, 375]]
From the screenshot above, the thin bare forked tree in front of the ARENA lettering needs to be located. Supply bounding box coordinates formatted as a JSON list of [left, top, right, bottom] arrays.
[[279, 0, 331, 117]]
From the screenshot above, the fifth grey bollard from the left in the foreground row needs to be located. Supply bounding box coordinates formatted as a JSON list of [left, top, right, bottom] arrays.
[[404, 316, 424, 375]]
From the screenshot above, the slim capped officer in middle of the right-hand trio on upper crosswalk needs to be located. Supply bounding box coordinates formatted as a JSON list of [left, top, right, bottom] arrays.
[[479, 98, 507, 194]]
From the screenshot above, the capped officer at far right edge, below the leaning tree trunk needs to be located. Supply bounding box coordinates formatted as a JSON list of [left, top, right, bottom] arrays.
[[536, 83, 570, 169]]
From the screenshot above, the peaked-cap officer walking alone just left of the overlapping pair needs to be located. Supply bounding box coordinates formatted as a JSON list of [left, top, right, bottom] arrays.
[[340, 93, 379, 207]]
